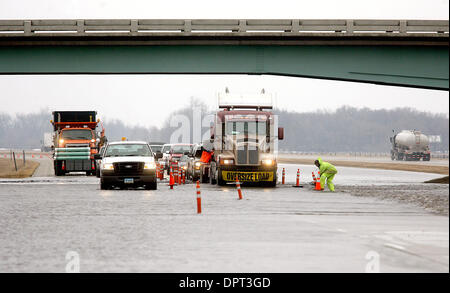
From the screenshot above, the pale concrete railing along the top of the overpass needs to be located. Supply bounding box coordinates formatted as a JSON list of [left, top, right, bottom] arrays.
[[0, 19, 449, 36]]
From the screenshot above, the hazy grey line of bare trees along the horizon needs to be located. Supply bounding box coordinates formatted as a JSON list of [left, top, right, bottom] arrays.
[[0, 99, 449, 152]]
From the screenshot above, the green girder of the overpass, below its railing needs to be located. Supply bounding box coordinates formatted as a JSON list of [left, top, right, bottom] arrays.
[[0, 45, 449, 89]]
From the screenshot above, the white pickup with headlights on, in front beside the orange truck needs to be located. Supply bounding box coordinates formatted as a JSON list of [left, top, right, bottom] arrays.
[[96, 141, 157, 190]]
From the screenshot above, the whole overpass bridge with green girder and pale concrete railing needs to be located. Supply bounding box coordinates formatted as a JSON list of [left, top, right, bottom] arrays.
[[0, 19, 449, 90]]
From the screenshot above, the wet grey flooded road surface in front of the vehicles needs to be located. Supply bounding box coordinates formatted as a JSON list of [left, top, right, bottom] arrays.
[[0, 157, 449, 272]]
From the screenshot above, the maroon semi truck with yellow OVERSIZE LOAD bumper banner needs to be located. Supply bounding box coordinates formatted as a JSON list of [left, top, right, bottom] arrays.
[[209, 89, 284, 187]]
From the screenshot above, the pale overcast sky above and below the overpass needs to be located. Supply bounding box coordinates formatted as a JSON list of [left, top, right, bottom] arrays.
[[0, 0, 449, 126]]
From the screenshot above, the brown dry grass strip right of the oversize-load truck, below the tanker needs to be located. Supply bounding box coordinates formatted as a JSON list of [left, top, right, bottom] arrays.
[[278, 158, 448, 175]]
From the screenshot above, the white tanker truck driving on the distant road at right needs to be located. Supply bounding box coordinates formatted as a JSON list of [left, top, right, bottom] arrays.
[[390, 130, 431, 161]]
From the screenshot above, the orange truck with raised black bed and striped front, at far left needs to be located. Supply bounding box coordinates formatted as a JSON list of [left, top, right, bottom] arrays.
[[50, 111, 106, 176]]
